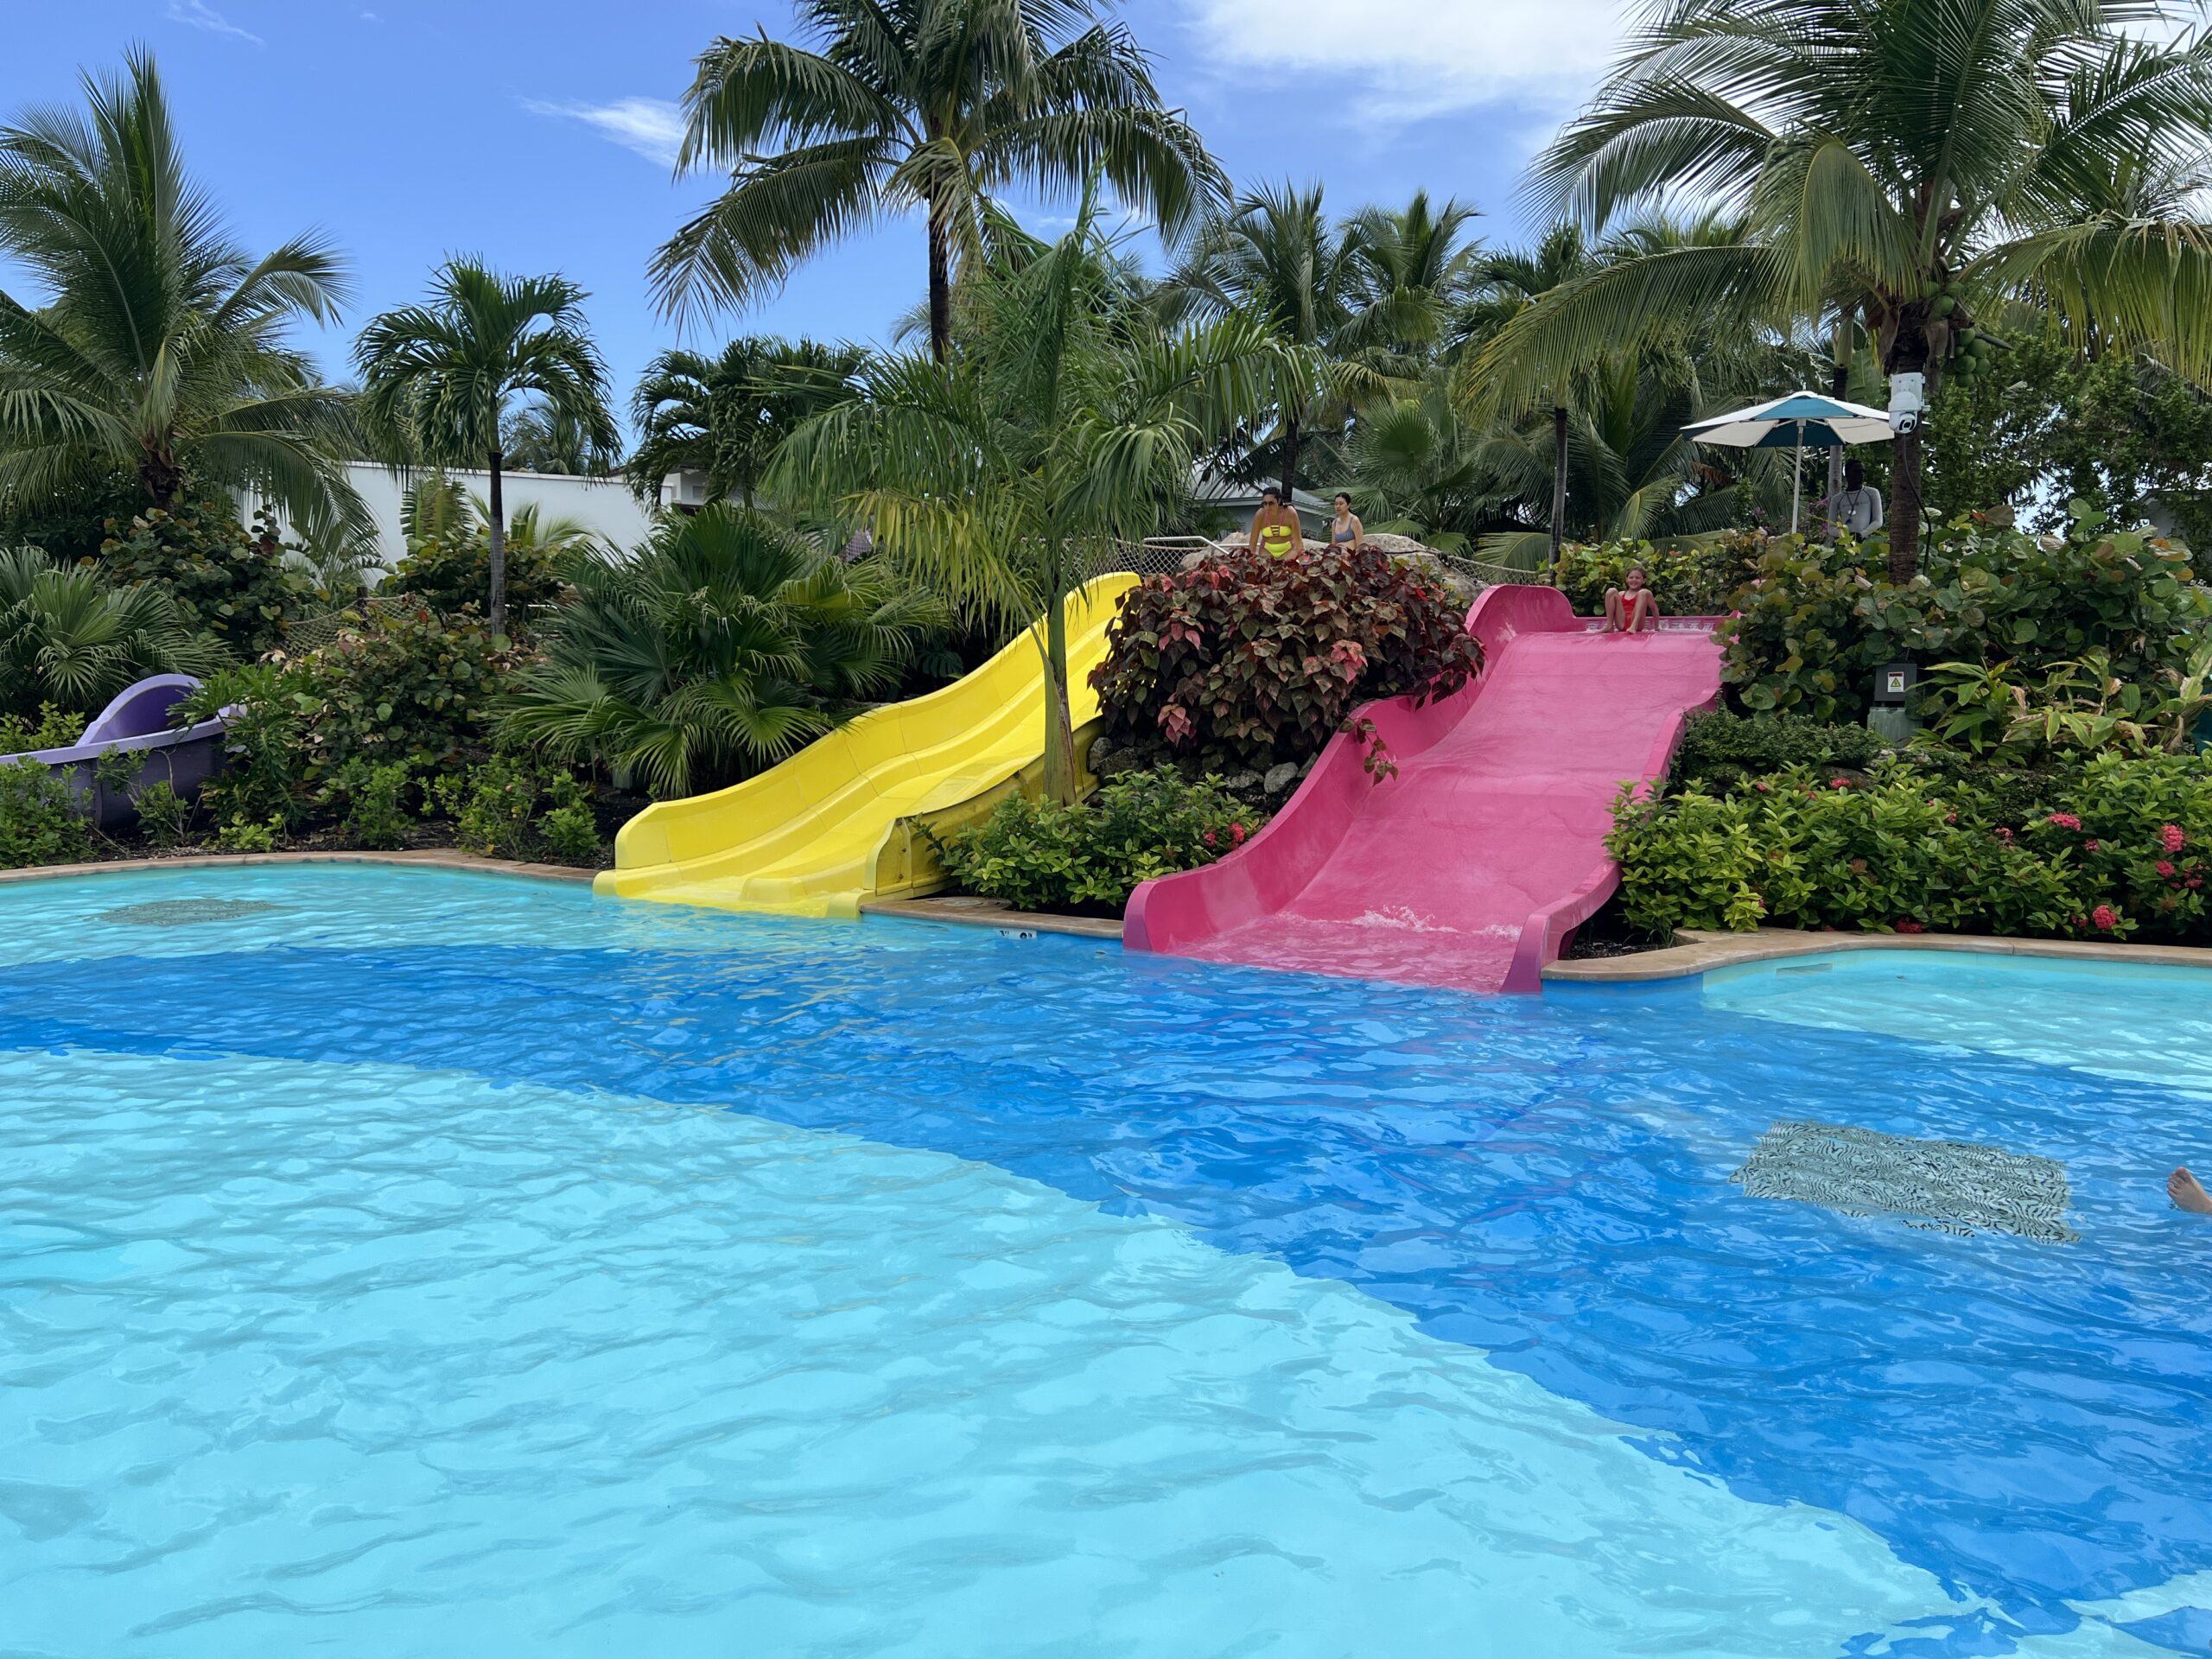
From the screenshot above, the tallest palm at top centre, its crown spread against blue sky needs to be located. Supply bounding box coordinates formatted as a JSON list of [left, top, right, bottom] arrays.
[[652, 0, 1221, 363]]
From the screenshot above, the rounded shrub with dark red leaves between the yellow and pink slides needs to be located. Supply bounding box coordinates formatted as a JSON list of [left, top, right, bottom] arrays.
[[1090, 549, 1482, 770]]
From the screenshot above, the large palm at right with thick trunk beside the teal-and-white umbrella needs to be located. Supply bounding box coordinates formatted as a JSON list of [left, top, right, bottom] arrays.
[[1476, 0, 2212, 582]]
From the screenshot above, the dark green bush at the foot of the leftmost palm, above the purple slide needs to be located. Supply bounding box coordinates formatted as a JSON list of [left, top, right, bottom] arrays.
[[99, 502, 323, 661]]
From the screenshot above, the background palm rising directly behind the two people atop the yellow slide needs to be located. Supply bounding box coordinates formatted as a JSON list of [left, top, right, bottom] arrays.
[[1161, 183, 1378, 502]]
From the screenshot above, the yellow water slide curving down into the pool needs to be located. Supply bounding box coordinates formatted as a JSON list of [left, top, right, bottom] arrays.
[[593, 575, 1137, 916]]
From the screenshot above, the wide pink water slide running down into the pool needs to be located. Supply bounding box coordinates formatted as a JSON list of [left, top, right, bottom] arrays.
[[1123, 586, 1721, 993]]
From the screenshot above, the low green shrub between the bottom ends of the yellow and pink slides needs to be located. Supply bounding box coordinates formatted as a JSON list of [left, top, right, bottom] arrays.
[[936, 772, 1265, 913]]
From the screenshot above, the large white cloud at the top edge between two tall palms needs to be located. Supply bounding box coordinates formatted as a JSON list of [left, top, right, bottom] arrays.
[[1192, 0, 1626, 119]]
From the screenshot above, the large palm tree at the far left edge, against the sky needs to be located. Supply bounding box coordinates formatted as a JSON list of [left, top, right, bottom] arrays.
[[0, 51, 367, 526]]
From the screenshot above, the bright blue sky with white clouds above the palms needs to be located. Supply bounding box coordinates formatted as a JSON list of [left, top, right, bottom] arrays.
[[0, 0, 1619, 435]]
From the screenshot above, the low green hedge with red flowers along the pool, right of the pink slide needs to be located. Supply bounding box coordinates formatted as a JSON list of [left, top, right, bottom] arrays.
[[1608, 754, 2212, 943]]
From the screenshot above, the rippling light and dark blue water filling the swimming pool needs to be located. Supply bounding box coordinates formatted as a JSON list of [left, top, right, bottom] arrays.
[[0, 868, 2212, 1659]]
